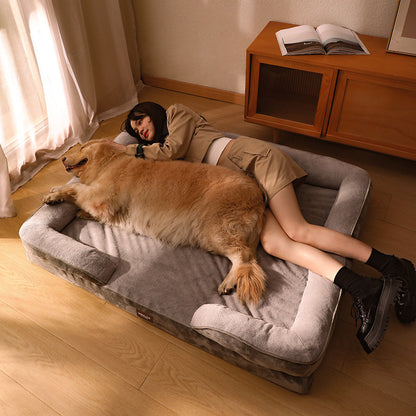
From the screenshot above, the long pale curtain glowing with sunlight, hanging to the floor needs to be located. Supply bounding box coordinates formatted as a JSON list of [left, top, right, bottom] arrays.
[[0, 0, 141, 217]]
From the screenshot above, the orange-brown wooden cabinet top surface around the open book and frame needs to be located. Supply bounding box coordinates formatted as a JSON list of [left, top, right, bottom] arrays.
[[247, 22, 416, 81]]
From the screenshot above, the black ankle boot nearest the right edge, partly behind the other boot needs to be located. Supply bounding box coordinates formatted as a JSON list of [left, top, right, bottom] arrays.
[[384, 257, 416, 323]]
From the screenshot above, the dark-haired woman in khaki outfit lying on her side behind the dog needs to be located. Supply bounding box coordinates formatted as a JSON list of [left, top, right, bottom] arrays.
[[117, 102, 416, 353]]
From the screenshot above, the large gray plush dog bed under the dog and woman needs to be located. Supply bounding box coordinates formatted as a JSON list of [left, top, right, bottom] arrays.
[[20, 133, 371, 393]]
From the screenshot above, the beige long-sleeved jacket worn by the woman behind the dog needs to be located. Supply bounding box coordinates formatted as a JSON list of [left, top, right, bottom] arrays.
[[127, 104, 224, 162]]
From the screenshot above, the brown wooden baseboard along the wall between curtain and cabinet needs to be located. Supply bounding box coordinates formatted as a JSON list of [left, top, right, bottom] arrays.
[[142, 75, 244, 105]]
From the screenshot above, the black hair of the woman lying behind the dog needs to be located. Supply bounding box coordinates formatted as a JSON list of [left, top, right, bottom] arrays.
[[121, 101, 169, 145]]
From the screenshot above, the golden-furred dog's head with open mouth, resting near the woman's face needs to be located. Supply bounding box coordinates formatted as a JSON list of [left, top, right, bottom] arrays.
[[62, 139, 123, 178]]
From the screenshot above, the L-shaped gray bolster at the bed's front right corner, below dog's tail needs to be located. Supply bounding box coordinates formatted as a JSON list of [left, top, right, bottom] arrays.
[[191, 273, 340, 376]]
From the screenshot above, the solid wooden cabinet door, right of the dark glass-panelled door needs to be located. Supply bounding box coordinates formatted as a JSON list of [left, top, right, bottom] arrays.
[[327, 71, 416, 159]]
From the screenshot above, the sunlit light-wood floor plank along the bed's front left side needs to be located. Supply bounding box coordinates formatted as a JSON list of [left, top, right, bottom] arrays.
[[0, 248, 171, 387]]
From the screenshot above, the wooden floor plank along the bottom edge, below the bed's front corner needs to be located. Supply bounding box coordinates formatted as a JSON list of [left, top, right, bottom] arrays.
[[142, 346, 413, 416]]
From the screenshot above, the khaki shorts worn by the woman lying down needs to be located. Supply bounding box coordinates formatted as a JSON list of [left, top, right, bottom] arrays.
[[218, 136, 306, 201]]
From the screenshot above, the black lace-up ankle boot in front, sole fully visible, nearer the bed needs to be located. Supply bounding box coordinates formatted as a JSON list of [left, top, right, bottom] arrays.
[[353, 277, 400, 354]]
